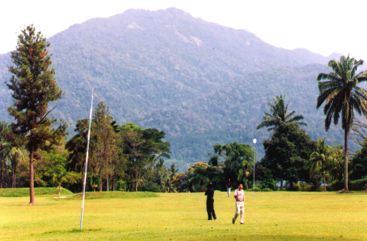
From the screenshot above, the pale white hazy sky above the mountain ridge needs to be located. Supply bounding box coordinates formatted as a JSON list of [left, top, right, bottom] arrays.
[[0, 0, 367, 61]]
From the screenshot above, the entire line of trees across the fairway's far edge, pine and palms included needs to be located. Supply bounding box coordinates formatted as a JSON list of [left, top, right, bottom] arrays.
[[0, 26, 367, 204]]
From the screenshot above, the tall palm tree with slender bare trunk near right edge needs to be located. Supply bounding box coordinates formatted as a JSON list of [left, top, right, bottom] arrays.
[[317, 56, 367, 192]]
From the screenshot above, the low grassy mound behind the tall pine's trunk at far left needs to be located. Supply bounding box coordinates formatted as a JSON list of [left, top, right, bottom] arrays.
[[0, 187, 73, 197]]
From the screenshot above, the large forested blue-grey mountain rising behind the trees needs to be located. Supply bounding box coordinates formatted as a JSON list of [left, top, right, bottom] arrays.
[[0, 8, 340, 169]]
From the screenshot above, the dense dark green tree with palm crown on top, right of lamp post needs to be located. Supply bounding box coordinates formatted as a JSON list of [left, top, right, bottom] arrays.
[[257, 96, 314, 189]]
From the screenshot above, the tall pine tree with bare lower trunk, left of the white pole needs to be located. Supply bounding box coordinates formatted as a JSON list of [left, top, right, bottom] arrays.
[[7, 25, 65, 204]]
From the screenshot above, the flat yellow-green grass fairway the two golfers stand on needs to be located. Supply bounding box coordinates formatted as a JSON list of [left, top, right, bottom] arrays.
[[0, 192, 367, 241]]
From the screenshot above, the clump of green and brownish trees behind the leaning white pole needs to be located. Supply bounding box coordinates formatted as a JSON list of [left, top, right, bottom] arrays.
[[65, 102, 172, 191]]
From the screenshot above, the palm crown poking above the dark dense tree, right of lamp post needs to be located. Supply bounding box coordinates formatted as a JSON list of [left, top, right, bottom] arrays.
[[256, 95, 306, 131]]
